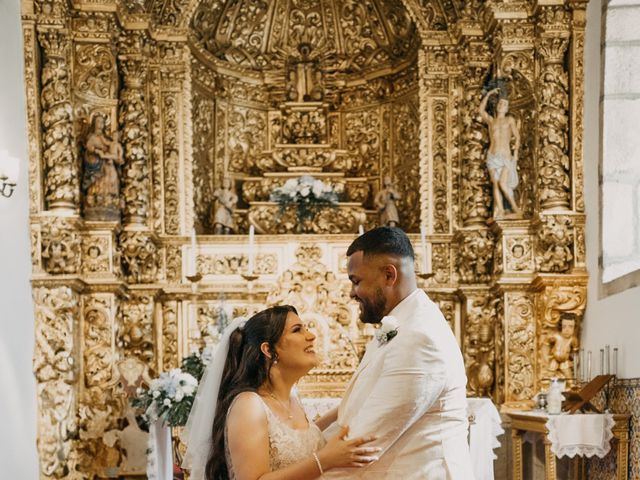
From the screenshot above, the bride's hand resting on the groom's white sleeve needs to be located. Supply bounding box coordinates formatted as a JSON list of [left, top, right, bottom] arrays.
[[318, 427, 381, 470]]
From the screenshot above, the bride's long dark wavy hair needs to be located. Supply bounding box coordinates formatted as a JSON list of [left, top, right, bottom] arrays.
[[205, 305, 298, 480]]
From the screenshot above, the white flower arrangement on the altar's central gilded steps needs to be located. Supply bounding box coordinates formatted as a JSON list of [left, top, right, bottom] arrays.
[[270, 175, 338, 223]]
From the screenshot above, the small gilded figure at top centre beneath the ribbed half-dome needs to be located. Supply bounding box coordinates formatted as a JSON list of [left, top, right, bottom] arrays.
[[286, 43, 324, 103]]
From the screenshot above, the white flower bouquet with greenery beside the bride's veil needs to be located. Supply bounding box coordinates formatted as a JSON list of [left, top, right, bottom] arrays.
[[131, 353, 207, 430]]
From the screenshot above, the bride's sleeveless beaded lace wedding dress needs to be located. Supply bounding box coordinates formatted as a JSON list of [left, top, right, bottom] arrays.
[[225, 398, 325, 480]]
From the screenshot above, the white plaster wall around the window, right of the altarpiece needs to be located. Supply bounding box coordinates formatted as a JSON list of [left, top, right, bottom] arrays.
[[582, 0, 640, 378]]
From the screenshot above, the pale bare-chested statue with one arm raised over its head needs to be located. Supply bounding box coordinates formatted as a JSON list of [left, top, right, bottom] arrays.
[[479, 87, 520, 219]]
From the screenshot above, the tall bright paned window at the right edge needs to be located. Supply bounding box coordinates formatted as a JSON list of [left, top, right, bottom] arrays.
[[600, 0, 640, 296]]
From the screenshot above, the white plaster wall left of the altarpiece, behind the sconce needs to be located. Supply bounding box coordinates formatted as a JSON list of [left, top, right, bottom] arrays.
[[0, 0, 38, 480]]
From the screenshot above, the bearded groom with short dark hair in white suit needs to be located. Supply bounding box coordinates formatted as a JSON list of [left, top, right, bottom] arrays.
[[325, 227, 473, 480]]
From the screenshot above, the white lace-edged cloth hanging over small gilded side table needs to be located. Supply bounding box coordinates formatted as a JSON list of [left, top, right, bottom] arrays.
[[546, 413, 615, 458]]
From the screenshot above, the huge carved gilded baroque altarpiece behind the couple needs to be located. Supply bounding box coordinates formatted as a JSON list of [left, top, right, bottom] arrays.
[[22, 0, 587, 478]]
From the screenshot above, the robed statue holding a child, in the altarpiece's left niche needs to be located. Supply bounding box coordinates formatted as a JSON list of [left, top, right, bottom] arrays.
[[82, 114, 124, 221]]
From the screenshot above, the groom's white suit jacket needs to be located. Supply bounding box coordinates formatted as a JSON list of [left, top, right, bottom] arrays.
[[325, 290, 473, 480]]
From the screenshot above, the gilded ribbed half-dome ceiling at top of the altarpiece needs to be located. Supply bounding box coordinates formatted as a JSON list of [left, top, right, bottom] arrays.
[[192, 0, 419, 74]]
